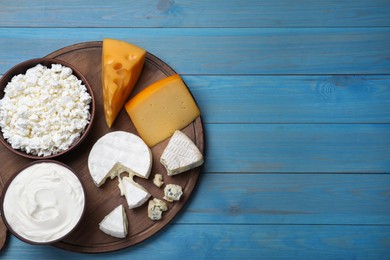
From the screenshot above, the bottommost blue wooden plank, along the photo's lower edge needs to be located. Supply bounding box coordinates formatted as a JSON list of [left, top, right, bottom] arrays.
[[1, 225, 390, 260]]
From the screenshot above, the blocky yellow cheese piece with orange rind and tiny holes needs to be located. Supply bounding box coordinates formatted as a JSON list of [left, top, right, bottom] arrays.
[[125, 74, 200, 147]]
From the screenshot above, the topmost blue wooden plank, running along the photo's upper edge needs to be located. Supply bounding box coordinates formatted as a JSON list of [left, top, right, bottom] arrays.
[[0, 0, 390, 27]]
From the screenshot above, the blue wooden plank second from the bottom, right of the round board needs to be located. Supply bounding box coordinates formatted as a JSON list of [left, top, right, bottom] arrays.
[[176, 173, 390, 225]]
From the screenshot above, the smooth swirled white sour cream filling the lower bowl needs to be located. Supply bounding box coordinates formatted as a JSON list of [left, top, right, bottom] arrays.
[[3, 162, 85, 243]]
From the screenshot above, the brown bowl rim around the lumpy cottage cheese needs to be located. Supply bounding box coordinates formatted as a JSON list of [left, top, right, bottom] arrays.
[[0, 58, 95, 160]]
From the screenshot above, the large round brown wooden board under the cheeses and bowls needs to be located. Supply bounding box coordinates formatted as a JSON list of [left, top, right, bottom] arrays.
[[0, 42, 204, 253]]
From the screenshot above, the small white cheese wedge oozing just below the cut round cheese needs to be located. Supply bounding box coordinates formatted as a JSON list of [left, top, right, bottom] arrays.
[[118, 176, 151, 209]]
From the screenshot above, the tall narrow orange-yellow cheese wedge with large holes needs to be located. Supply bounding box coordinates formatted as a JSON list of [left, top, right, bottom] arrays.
[[102, 39, 146, 127]]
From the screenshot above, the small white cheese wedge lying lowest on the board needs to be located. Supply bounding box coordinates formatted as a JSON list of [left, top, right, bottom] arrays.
[[99, 205, 128, 238]]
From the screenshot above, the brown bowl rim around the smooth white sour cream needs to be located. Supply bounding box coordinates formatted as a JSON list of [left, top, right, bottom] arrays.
[[0, 160, 87, 245]]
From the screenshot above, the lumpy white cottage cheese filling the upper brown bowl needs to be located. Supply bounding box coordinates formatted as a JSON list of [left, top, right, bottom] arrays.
[[0, 64, 92, 156]]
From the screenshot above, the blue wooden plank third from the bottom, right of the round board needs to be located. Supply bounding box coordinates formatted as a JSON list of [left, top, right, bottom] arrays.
[[205, 124, 390, 173]]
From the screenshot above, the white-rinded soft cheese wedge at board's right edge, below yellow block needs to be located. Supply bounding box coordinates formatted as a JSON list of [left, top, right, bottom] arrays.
[[160, 130, 203, 176]]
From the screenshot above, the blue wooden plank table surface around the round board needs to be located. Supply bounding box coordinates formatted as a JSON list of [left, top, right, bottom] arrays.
[[0, 0, 390, 259]]
